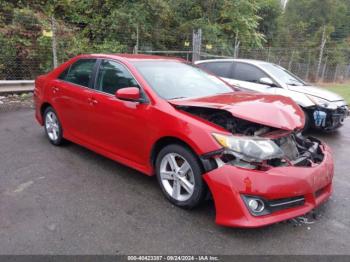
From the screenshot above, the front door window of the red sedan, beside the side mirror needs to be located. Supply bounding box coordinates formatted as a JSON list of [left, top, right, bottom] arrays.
[[97, 60, 139, 95]]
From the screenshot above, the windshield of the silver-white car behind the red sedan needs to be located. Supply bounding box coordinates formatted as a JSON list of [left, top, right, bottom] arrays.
[[261, 63, 306, 86]]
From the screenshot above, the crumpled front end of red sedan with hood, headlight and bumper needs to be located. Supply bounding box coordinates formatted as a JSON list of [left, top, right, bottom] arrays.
[[177, 96, 334, 227]]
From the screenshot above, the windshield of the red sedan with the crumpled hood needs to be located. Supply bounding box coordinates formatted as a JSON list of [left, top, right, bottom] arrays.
[[133, 61, 233, 100]]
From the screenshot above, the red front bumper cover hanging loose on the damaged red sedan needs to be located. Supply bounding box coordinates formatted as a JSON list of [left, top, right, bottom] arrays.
[[203, 143, 334, 228]]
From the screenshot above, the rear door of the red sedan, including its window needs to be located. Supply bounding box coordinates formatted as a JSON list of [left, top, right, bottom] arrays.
[[51, 59, 96, 141]]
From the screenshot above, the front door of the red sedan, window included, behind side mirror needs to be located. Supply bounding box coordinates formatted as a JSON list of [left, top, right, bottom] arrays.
[[87, 59, 152, 165]]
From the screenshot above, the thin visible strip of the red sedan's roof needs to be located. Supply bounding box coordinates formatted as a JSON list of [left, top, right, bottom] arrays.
[[79, 54, 186, 62]]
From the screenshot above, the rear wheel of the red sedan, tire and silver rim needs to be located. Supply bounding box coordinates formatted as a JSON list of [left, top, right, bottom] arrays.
[[44, 107, 64, 146]]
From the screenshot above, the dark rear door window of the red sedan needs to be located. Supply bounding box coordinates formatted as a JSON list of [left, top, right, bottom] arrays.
[[59, 59, 96, 87]]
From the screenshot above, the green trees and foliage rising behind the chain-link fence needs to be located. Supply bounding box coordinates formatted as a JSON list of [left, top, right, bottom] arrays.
[[0, 0, 350, 78]]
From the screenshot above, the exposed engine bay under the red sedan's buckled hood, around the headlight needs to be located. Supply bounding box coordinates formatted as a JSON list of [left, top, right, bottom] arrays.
[[178, 106, 324, 169]]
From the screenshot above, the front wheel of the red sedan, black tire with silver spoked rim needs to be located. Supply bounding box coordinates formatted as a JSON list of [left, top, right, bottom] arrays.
[[156, 144, 207, 209]]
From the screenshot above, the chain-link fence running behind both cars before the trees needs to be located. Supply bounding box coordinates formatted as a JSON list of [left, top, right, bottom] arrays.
[[0, 10, 350, 82]]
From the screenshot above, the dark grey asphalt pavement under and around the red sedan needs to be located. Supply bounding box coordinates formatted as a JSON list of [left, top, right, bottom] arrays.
[[0, 109, 350, 254]]
